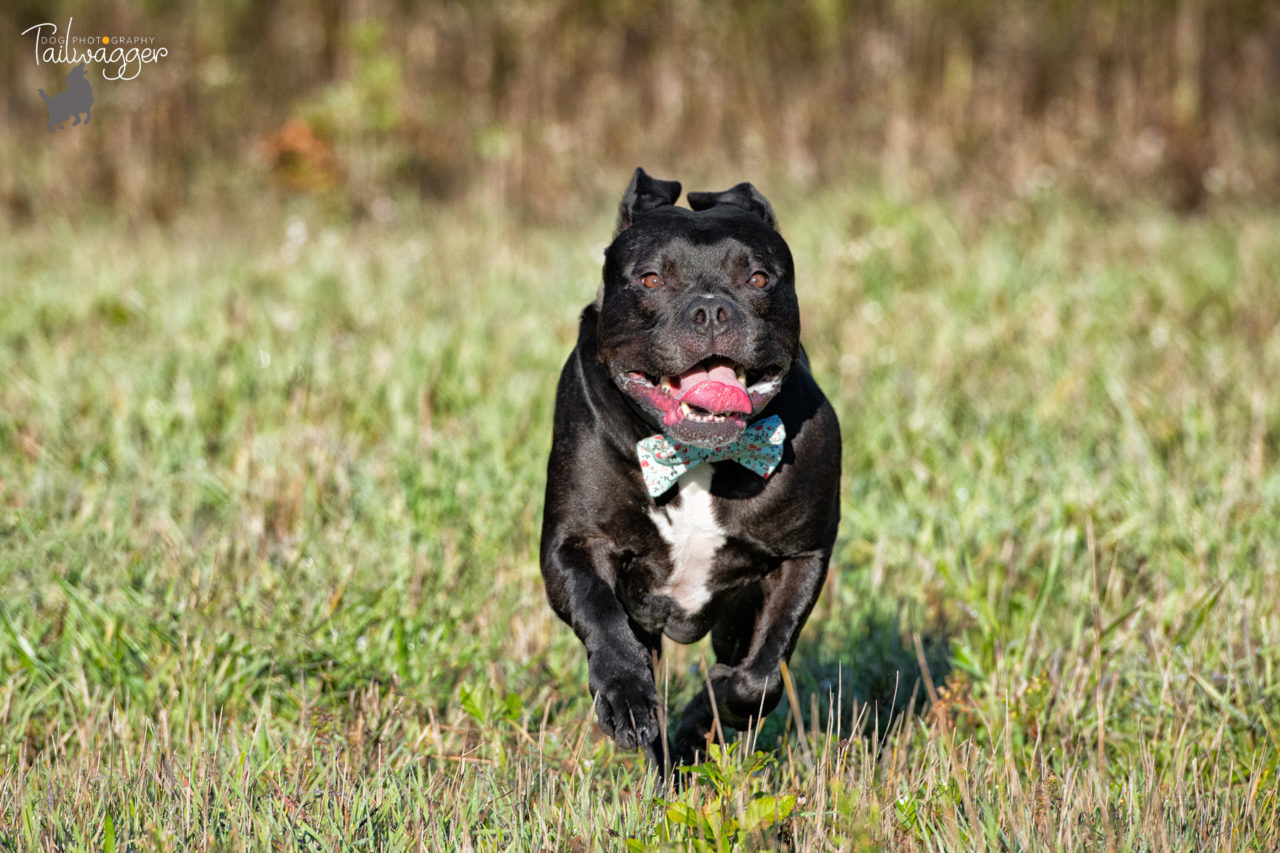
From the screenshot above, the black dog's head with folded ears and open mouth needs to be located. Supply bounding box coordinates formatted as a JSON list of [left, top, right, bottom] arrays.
[[598, 169, 800, 447]]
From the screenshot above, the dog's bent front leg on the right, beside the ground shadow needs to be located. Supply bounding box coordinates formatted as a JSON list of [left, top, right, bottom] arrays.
[[673, 551, 831, 763]]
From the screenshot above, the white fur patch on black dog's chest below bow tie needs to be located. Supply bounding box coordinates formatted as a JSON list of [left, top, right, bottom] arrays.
[[649, 465, 724, 613]]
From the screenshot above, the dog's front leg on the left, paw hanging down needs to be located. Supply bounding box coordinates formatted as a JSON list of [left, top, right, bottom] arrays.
[[543, 543, 662, 758]]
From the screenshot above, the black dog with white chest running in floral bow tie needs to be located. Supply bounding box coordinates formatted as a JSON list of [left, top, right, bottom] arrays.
[[541, 169, 840, 765]]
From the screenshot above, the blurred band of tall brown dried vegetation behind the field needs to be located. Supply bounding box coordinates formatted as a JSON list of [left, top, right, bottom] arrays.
[[0, 0, 1280, 223]]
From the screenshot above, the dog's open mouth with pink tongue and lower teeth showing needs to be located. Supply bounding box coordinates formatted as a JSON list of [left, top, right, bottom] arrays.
[[620, 356, 786, 444]]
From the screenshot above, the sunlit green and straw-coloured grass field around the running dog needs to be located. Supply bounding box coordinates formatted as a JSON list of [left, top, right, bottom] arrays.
[[0, 184, 1280, 852]]
